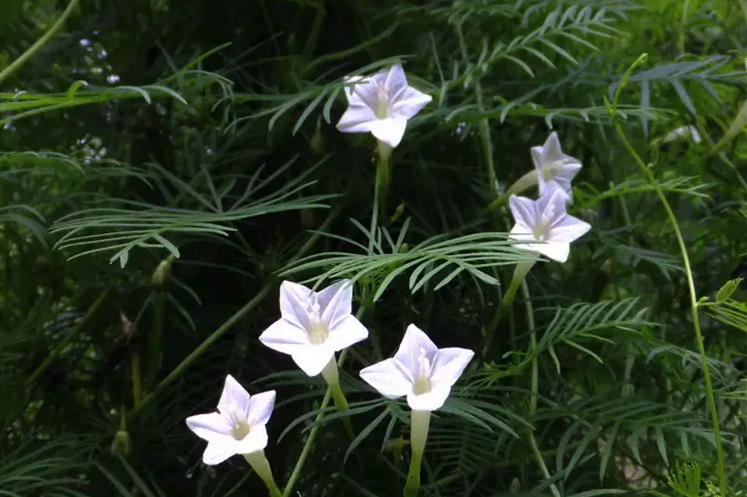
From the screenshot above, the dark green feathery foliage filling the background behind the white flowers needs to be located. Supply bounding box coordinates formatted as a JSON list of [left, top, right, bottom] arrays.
[[0, 0, 747, 497]]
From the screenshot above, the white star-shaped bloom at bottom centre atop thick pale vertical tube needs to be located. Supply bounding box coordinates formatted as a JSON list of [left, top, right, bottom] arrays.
[[360, 324, 475, 411]]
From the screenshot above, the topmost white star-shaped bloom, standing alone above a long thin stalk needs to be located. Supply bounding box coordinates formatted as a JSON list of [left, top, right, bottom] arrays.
[[337, 64, 432, 148]]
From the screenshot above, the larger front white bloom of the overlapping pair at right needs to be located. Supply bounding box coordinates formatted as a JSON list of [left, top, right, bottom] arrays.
[[509, 183, 591, 262]]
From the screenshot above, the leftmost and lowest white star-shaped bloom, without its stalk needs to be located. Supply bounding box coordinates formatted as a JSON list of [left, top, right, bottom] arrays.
[[187, 375, 275, 465]]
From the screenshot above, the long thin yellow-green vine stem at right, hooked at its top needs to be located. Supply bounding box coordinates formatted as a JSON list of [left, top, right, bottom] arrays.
[[610, 54, 727, 496]]
